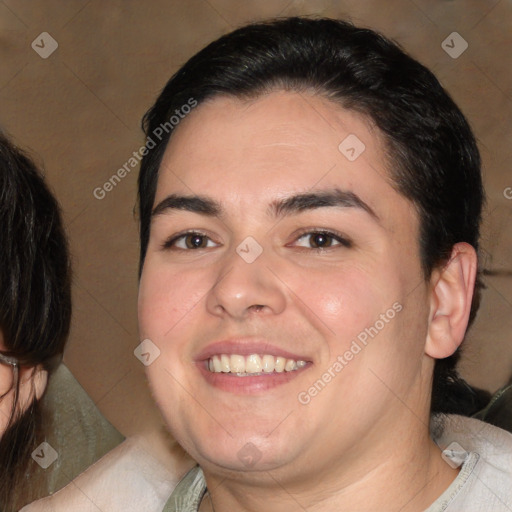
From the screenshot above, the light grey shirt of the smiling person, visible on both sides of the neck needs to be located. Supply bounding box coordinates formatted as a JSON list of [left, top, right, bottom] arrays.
[[162, 415, 512, 512]]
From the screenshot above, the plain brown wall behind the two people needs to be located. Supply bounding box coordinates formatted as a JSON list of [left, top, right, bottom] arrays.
[[0, 0, 512, 435]]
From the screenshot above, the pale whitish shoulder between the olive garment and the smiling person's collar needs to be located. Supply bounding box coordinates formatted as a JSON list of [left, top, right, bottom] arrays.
[[21, 437, 196, 512]]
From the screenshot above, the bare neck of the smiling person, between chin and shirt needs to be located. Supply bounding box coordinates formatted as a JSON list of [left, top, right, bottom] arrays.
[[200, 418, 459, 512]]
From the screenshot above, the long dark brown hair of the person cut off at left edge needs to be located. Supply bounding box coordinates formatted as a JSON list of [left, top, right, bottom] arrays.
[[0, 133, 71, 512]]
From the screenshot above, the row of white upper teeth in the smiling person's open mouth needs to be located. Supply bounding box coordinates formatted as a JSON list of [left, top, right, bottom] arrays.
[[208, 354, 307, 377]]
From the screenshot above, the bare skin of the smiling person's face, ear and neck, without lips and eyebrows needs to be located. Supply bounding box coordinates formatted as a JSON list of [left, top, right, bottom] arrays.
[[139, 91, 476, 512]]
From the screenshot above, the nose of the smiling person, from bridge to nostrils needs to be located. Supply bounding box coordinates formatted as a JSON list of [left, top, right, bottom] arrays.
[[207, 236, 285, 318]]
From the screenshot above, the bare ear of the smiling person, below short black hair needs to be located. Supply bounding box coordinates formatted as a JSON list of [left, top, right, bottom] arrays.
[[425, 242, 478, 359]]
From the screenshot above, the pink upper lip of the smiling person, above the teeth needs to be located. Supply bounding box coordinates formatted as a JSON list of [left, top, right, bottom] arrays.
[[197, 338, 311, 362]]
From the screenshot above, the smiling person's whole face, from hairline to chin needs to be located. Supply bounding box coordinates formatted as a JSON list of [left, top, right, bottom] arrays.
[[139, 92, 430, 478]]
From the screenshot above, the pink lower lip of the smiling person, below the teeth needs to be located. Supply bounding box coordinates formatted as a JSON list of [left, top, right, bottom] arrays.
[[197, 361, 311, 395]]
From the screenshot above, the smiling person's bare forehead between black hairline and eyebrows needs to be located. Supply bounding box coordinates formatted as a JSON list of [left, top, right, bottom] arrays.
[[155, 91, 412, 230]]
